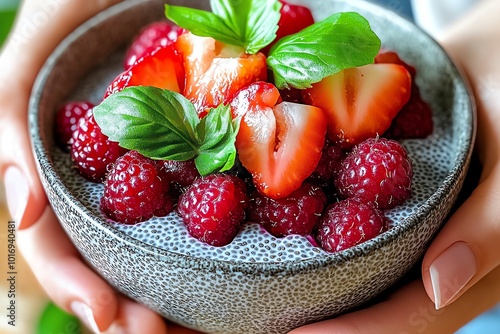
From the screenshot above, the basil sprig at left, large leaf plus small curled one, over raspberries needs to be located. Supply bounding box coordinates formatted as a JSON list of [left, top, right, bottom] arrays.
[[93, 86, 239, 175]]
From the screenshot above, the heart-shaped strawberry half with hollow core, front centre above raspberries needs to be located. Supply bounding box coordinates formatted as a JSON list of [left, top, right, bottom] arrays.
[[231, 82, 327, 198]]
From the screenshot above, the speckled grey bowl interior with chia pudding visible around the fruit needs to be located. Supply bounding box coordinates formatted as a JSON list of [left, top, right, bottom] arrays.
[[30, 0, 475, 264]]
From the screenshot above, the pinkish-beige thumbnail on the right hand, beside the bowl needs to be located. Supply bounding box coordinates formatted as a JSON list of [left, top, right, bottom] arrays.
[[429, 242, 476, 310]]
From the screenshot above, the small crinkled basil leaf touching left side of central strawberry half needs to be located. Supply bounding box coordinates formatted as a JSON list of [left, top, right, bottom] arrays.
[[195, 105, 240, 175]]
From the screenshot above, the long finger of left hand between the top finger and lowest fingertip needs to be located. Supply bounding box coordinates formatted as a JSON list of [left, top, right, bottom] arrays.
[[17, 206, 117, 332]]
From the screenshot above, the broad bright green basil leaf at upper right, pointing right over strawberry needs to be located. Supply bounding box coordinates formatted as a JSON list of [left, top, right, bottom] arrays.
[[267, 12, 380, 89]]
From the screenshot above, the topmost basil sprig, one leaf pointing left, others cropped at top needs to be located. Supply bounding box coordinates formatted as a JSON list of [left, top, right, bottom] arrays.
[[165, 0, 281, 54]]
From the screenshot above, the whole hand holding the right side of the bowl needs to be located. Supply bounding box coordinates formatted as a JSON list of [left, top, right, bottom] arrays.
[[291, 1, 500, 334]]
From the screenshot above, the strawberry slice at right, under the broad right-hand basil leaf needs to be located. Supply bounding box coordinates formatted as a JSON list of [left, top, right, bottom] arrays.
[[303, 64, 411, 148]]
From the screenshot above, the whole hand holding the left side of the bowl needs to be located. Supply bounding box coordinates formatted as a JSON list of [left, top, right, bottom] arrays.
[[0, 0, 185, 334]]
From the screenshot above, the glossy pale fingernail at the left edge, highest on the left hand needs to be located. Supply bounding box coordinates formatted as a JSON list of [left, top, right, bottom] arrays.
[[4, 167, 30, 226]]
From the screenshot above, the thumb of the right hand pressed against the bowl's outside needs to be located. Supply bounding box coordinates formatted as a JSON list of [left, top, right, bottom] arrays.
[[422, 170, 500, 309]]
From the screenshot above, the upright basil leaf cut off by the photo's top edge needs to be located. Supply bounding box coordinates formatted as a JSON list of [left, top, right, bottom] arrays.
[[210, 0, 282, 54]]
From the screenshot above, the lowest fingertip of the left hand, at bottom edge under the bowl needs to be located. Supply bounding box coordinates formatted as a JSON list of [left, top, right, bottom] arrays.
[[106, 296, 168, 334]]
